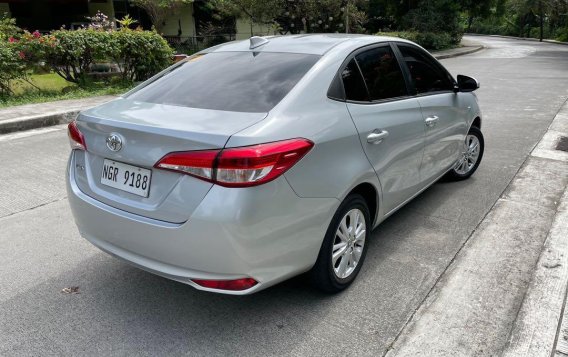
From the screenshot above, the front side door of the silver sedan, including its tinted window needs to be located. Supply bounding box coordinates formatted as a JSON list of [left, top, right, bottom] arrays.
[[397, 43, 468, 185]]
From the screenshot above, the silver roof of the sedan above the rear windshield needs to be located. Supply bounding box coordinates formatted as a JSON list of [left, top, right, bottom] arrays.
[[203, 33, 408, 56]]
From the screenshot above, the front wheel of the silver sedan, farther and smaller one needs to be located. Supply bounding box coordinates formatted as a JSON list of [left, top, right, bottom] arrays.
[[445, 126, 485, 181]]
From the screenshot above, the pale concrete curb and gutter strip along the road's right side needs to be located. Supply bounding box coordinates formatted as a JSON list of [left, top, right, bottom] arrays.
[[387, 102, 568, 357]]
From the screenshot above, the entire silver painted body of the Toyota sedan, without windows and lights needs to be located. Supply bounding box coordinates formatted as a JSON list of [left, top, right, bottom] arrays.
[[67, 34, 480, 294]]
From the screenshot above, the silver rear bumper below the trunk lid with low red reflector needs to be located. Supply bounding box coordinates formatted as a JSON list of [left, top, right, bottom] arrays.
[[67, 154, 340, 295]]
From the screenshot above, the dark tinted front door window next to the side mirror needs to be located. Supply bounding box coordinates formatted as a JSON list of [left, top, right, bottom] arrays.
[[397, 44, 454, 94]]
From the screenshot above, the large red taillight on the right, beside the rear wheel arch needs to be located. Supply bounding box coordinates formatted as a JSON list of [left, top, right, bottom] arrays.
[[155, 139, 314, 187]]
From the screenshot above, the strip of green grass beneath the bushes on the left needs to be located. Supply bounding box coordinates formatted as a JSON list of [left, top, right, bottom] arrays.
[[0, 73, 132, 108]]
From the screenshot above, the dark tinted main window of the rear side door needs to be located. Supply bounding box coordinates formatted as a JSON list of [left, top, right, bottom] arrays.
[[355, 46, 408, 101]]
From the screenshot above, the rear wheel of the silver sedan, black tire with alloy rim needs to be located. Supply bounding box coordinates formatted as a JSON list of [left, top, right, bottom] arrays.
[[310, 194, 372, 293]]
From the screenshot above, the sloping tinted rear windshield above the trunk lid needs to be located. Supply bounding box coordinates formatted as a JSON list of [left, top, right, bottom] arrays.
[[128, 52, 320, 113]]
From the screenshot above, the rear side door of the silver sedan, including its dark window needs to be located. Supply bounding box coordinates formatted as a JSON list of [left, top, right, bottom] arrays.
[[341, 44, 424, 214]]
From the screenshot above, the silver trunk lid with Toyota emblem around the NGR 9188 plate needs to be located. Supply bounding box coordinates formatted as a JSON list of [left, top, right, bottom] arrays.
[[74, 98, 266, 223]]
